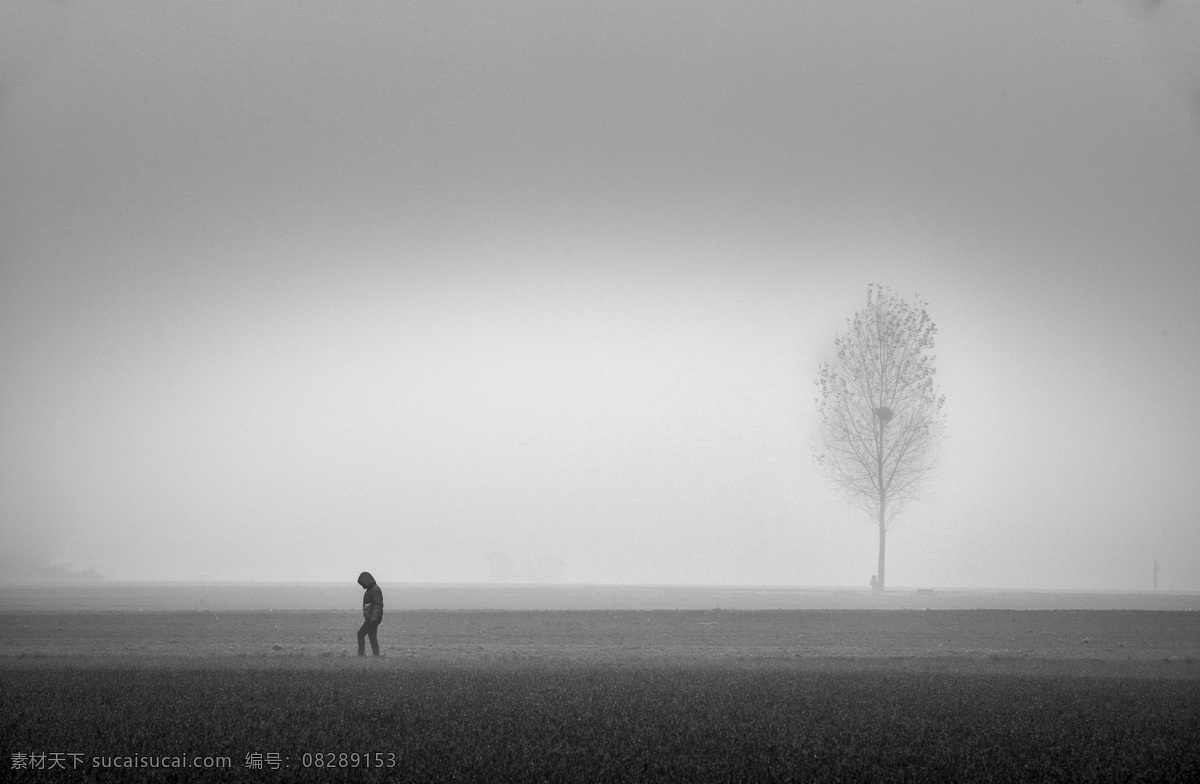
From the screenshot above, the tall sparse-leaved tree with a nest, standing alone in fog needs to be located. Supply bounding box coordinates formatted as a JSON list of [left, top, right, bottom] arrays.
[[814, 283, 946, 591]]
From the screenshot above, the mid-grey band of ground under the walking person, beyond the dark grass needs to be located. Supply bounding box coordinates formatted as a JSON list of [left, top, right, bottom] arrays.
[[0, 610, 1200, 663]]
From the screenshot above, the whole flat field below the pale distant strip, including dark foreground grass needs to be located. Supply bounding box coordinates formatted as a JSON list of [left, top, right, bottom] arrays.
[[0, 583, 1200, 782]]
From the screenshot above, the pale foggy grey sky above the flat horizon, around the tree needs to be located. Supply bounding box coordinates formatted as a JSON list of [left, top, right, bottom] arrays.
[[0, 0, 1200, 591]]
